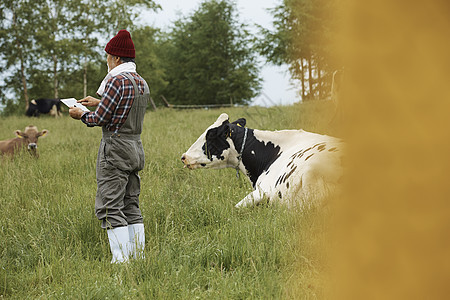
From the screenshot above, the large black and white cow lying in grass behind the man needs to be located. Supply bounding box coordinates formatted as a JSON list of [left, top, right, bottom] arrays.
[[181, 114, 344, 207]]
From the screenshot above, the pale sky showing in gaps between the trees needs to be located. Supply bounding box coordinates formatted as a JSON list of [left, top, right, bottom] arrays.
[[143, 0, 300, 106]]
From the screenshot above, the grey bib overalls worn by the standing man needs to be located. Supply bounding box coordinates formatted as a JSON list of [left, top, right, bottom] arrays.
[[95, 73, 150, 229]]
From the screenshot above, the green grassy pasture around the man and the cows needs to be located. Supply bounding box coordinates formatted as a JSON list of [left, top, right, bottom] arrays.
[[0, 102, 333, 299]]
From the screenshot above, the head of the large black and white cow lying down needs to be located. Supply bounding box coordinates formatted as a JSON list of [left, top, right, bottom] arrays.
[[181, 114, 245, 169]]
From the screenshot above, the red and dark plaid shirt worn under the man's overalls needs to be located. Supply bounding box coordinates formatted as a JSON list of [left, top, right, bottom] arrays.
[[81, 73, 144, 132]]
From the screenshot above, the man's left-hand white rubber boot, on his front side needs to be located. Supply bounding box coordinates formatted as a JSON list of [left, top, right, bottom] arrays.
[[106, 226, 130, 264]]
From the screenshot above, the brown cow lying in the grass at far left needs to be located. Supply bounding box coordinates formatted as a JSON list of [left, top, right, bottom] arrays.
[[0, 125, 48, 158]]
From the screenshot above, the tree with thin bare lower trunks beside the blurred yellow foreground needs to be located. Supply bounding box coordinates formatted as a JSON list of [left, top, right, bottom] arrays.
[[258, 0, 339, 100]]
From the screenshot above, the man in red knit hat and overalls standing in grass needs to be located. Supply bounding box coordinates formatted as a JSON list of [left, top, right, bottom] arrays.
[[69, 30, 150, 263]]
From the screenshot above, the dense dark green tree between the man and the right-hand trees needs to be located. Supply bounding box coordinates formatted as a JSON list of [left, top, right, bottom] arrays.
[[163, 0, 260, 104]]
